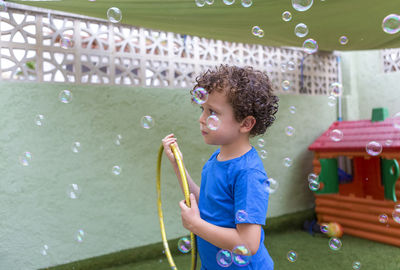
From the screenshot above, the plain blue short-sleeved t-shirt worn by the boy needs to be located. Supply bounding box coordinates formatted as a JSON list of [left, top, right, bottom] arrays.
[[197, 147, 274, 270]]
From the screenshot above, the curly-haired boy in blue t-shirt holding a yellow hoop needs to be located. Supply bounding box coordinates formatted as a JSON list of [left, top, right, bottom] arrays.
[[162, 65, 279, 270]]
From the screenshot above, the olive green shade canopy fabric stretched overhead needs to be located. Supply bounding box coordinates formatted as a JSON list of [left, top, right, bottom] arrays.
[[9, 0, 400, 51]]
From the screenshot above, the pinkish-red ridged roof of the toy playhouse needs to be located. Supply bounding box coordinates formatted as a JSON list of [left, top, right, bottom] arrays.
[[308, 118, 400, 154]]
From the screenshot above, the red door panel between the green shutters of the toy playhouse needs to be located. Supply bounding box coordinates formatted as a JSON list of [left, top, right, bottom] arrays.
[[353, 157, 385, 200]]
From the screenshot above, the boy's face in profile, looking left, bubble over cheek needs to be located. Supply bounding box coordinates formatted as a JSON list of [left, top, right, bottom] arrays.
[[199, 91, 241, 145]]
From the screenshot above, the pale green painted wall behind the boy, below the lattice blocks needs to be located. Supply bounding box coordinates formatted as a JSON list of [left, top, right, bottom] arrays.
[[0, 79, 336, 269]]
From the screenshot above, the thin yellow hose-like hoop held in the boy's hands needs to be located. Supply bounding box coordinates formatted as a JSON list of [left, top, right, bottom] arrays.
[[157, 144, 197, 270]]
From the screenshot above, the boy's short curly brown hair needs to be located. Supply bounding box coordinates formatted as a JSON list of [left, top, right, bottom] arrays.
[[190, 65, 279, 137]]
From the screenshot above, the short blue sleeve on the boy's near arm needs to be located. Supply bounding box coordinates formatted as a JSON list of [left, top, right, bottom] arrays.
[[234, 169, 269, 225]]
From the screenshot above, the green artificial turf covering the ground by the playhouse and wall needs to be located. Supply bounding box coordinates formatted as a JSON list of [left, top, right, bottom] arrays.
[[107, 231, 400, 270]]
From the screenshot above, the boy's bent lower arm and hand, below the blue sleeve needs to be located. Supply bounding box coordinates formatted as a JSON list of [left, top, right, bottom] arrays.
[[180, 195, 261, 255]]
